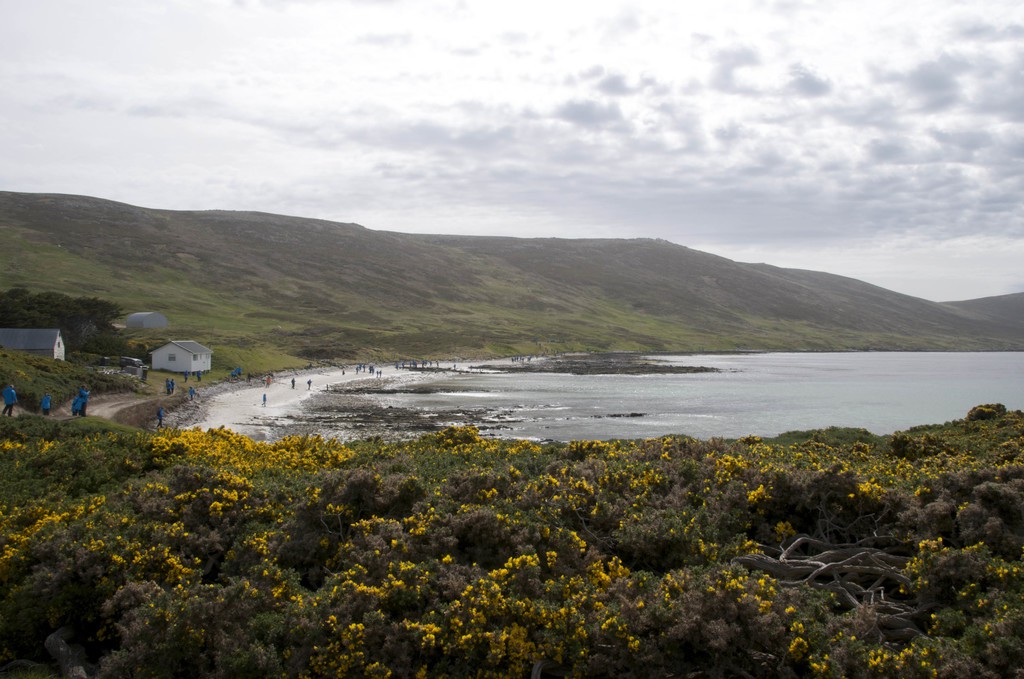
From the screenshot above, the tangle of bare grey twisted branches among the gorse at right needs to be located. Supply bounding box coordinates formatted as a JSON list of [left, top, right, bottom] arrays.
[[733, 535, 924, 642]]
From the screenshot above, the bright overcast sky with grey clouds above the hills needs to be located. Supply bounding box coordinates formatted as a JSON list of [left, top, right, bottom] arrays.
[[0, 0, 1024, 300]]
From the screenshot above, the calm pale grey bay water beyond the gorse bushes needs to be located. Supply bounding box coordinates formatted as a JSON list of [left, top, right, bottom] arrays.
[[385, 352, 1024, 440]]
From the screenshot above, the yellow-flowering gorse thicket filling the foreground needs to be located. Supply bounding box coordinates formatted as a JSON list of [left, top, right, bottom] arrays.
[[0, 405, 1024, 678]]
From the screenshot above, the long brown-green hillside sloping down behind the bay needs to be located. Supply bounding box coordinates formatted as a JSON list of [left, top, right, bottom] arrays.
[[0, 187, 1024, 357]]
